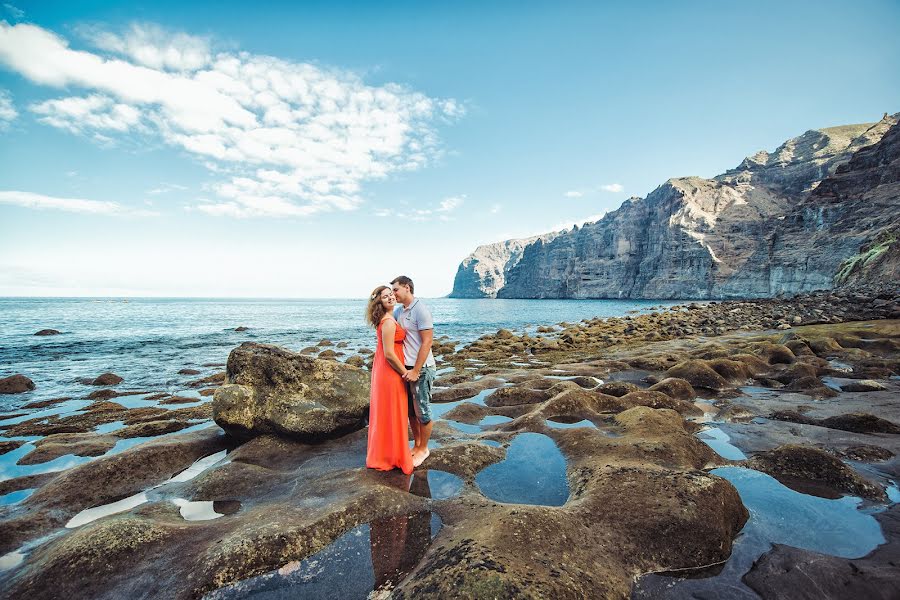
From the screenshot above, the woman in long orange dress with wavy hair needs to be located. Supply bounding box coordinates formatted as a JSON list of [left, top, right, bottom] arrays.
[[366, 285, 413, 475]]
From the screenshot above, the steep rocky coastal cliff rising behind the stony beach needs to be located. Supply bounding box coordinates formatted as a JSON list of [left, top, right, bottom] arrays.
[[451, 113, 900, 299]]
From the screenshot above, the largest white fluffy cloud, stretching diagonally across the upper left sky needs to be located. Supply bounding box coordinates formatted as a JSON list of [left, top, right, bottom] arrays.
[[0, 22, 465, 217]]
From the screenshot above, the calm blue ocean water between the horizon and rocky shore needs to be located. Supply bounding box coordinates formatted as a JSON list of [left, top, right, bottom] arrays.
[[0, 298, 674, 412]]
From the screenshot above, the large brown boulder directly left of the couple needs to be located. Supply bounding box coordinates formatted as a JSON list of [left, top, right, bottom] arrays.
[[213, 342, 369, 441]]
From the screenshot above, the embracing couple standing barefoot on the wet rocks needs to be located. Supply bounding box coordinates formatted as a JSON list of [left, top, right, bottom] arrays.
[[366, 275, 436, 475]]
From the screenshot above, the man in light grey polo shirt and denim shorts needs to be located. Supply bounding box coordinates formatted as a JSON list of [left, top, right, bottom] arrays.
[[391, 275, 437, 467]]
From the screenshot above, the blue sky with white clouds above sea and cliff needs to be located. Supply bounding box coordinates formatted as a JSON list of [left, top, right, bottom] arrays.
[[0, 0, 900, 298]]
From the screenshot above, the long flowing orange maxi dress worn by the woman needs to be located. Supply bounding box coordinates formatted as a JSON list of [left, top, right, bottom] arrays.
[[366, 317, 413, 475]]
